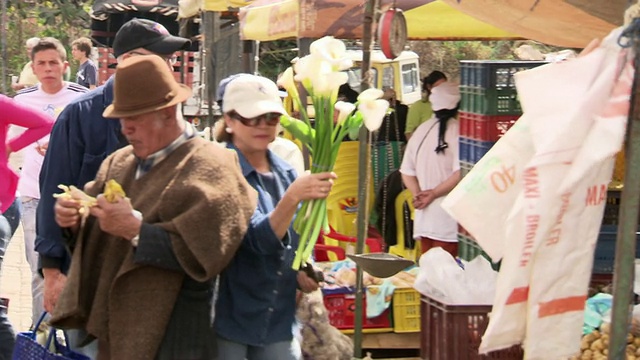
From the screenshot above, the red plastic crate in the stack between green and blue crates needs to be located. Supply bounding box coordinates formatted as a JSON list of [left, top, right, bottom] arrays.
[[458, 111, 520, 142]]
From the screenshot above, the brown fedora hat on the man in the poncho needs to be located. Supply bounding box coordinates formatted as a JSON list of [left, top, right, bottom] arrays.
[[102, 55, 191, 118]]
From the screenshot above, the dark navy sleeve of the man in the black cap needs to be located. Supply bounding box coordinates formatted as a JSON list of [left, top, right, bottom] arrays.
[[35, 102, 84, 272]]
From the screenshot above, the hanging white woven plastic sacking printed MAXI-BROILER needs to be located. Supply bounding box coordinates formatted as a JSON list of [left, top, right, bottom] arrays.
[[442, 26, 633, 359]]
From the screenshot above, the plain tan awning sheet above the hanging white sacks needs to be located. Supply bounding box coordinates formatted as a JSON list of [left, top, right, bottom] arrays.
[[442, 0, 628, 48]]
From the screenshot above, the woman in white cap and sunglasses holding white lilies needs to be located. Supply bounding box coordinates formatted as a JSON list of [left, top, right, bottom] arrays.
[[215, 75, 336, 360]]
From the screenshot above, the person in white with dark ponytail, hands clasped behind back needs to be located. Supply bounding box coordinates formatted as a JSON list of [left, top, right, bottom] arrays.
[[400, 82, 460, 257]]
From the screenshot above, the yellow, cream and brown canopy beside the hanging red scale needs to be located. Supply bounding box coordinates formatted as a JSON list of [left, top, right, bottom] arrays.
[[240, 0, 522, 41]]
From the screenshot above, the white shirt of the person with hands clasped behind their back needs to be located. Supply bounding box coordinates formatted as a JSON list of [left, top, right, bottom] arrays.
[[400, 116, 460, 242]]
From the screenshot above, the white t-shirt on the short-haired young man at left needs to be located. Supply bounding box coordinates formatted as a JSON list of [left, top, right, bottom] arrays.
[[14, 82, 89, 199]]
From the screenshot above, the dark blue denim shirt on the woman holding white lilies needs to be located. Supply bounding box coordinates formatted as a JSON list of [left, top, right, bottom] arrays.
[[215, 144, 298, 346]]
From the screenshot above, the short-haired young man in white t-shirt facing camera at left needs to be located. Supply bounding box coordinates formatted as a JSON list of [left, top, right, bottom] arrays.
[[15, 38, 89, 323]]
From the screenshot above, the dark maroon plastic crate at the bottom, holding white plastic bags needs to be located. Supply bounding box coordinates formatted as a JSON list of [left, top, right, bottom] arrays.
[[420, 296, 524, 360]]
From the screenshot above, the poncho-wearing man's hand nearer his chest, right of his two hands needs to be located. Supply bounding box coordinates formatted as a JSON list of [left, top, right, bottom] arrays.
[[91, 195, 142, 240]]
